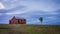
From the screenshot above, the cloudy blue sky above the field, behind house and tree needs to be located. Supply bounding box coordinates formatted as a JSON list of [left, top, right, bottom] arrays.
[[0, 0, 60, 25]]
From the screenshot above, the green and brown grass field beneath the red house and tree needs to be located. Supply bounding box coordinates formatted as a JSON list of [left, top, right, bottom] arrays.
[[0, 24, 60, 34]]
